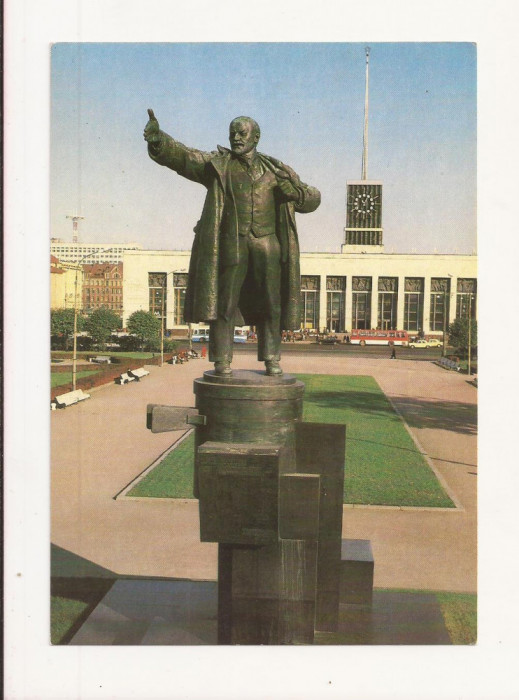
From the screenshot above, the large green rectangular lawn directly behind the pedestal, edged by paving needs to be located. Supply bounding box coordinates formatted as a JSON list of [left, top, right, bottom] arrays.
[[128, 374, 454, 508]]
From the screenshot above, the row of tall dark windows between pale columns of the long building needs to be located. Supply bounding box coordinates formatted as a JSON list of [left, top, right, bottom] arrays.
[[148, 272, 477, 333]]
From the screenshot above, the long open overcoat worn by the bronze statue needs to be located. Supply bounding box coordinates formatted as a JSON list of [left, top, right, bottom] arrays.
[[148, 131, 321, 329]]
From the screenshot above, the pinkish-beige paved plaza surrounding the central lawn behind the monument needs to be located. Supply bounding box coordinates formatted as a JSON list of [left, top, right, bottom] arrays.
[[51, 352, 477, 592]]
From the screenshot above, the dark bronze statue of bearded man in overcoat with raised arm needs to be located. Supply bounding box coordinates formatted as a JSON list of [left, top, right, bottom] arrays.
[[144, 110, 321, 376]]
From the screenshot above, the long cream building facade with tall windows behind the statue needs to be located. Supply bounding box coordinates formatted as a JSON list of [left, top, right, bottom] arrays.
[[123, 246, 477, 337]]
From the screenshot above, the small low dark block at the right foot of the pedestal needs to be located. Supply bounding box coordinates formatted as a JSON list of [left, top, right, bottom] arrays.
[[339, 540, 375, 605]]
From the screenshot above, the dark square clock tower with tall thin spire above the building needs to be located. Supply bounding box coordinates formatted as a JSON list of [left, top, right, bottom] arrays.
[[341, 47, 384, 253]]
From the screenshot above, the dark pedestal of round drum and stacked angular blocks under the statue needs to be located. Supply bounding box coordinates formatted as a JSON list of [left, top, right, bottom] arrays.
[[195, 371, 345, 644]]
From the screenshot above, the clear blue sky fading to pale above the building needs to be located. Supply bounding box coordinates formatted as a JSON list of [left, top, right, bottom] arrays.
[[51, 43, 476, 253]]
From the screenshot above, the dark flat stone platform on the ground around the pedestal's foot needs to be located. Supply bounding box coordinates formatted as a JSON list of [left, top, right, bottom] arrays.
[[69, 579, 451, 646]]
